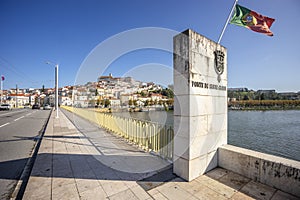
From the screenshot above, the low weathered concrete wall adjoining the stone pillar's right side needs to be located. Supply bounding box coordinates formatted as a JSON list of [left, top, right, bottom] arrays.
[[218, 145, 300, 197]]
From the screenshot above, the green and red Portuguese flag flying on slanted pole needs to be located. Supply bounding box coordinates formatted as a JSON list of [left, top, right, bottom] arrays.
[[230, 4, 275, 36]]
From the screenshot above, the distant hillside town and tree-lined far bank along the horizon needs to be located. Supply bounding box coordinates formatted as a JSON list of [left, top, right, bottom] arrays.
[[0, 74, 300, 108]]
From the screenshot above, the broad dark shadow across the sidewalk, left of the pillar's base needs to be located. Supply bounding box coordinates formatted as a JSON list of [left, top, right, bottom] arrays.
[[27, 153, 171, 181]]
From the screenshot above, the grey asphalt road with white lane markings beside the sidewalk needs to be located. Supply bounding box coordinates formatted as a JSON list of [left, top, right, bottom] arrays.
[[0, 109, 50, 200]]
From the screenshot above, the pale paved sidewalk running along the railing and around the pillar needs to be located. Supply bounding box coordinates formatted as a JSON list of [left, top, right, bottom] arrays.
[[23, 111, 298, 200]]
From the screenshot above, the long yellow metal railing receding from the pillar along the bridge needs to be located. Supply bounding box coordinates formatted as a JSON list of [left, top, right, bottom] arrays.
[[61, 106, 174, 161]]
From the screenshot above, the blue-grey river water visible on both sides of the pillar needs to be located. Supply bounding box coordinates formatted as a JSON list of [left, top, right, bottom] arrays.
[[110, 110, 300, 161]]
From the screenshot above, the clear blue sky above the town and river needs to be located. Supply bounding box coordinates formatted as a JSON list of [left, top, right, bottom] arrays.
[[0, 0, 300, 91]]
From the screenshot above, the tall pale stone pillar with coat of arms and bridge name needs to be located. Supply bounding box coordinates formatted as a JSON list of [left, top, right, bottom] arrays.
[[173, 29, 227, 181]]
